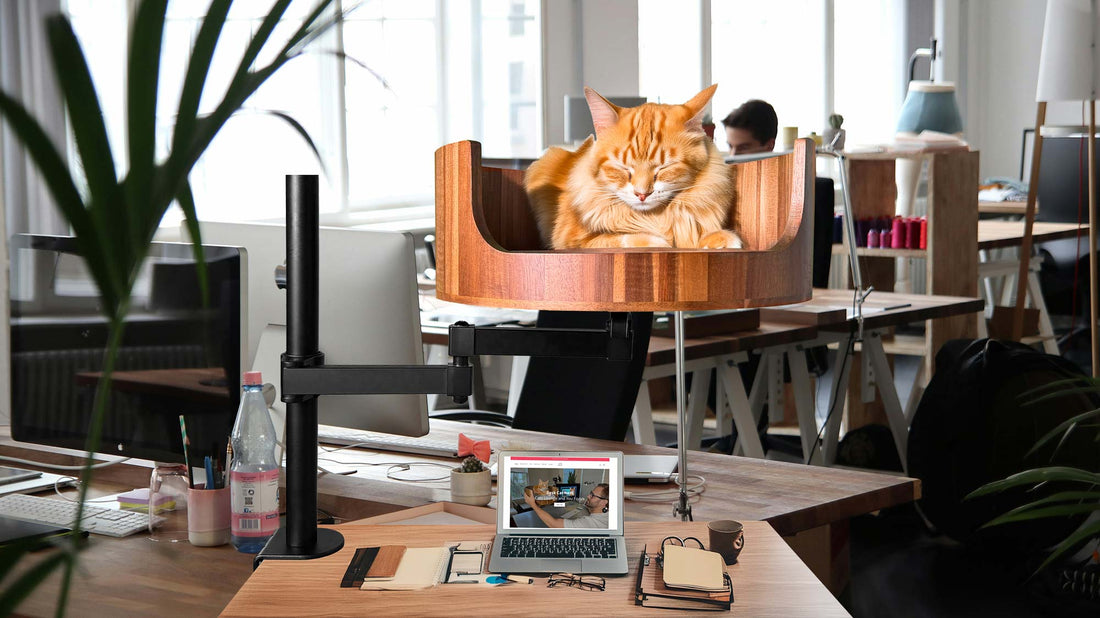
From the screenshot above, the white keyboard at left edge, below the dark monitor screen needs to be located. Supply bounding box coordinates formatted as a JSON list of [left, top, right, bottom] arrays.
[[0, 494, 164, 537]]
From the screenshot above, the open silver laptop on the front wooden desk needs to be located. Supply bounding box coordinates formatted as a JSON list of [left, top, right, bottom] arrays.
[[488, 451, 627, 575]]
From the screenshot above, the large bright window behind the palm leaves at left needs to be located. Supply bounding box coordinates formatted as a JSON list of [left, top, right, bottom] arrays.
[[67, 0, 541, 225]]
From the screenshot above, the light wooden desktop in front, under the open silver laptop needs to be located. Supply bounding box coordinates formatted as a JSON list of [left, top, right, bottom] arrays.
[[222, 521, 848, 618]]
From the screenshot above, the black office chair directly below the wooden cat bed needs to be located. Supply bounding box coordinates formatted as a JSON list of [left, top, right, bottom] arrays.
[[430, 311, 653, 442]]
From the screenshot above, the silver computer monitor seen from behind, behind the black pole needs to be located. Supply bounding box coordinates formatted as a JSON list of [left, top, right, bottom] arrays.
[[202, 222, 428, 440]]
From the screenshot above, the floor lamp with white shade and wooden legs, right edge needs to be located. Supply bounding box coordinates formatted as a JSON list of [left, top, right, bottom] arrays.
[[1012, 0, 1100, 377]]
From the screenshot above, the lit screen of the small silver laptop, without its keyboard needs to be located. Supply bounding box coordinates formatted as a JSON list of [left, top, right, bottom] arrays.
[[497, 453, 623, 532]]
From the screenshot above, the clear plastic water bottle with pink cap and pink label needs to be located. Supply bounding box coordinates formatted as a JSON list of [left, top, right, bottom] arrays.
[[229, 372, 279, 553]]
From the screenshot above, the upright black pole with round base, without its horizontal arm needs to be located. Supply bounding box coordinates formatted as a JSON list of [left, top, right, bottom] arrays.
[[254, 175, 343, 565]]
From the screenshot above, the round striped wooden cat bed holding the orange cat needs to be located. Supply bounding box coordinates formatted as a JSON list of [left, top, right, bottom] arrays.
[[436, 140, 814, 311]]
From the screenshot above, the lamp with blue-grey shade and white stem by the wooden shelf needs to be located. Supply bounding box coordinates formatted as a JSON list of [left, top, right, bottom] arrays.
[[894, 38, 963, 293]]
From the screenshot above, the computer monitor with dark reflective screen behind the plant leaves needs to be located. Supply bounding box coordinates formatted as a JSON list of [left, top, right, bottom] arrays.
[[9, 234, 246, 463]]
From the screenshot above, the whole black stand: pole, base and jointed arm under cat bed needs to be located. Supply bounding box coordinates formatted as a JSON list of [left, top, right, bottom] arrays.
[[253, 175, 634, 566]]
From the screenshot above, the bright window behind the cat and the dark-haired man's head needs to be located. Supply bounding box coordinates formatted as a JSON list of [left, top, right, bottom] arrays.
[[638, 0, 906, 150]]
